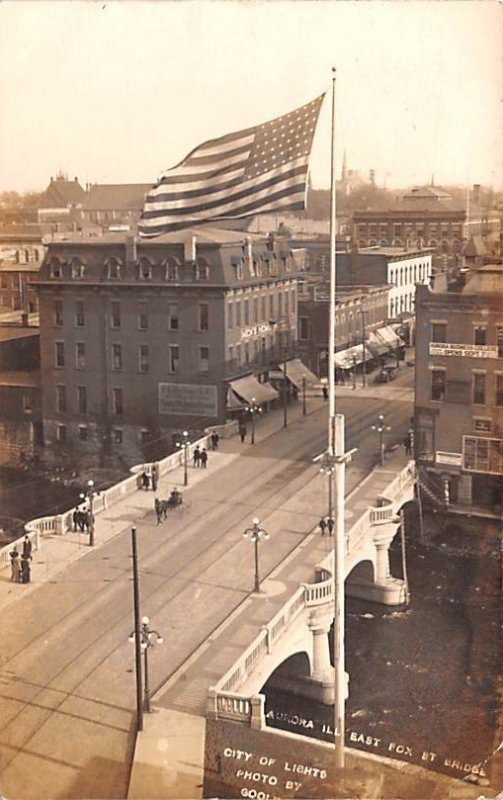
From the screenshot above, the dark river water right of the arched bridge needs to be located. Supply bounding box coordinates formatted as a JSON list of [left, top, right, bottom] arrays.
[[264, 514, 501, 778]]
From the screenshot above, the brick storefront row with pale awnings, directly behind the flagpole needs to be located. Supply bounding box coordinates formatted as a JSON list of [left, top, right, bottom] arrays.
[[297, 280, 392, 377]]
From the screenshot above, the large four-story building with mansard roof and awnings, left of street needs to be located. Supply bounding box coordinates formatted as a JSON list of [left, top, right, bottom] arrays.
[[37, 226, 304, 461]]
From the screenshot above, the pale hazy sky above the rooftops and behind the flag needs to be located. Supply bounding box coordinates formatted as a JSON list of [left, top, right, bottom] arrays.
[[0, 0, 503, 192]]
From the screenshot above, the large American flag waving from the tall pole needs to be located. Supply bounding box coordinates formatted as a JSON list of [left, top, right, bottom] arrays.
[[138, 94, 324, 236]]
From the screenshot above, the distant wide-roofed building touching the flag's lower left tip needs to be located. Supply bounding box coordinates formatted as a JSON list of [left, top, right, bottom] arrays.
[[81, 183, 151, 233]]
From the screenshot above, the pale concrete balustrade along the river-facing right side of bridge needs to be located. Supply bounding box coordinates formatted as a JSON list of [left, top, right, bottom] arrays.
[[207, 462, 415, 728]]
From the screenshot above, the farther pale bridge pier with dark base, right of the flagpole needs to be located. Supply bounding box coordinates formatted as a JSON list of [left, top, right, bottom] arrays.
[[346, 520, 406, 606]]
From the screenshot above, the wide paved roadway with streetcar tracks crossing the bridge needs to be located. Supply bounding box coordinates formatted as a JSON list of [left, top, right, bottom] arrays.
[[0, 373, 411, 800]]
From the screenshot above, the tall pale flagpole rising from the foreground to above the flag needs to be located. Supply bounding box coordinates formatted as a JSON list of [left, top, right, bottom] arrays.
[[328, 67, 346, 768]]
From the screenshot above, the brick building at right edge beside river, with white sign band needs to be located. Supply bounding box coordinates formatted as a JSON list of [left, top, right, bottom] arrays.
[[415, 265, 503, 515]]
